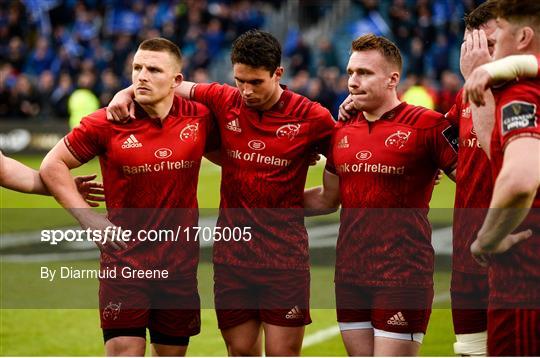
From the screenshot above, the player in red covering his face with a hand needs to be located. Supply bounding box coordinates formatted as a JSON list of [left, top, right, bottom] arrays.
[[438, 1, 497, 356]]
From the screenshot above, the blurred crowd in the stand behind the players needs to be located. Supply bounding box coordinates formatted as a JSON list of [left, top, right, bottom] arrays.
[[0, 0, 482, 121]]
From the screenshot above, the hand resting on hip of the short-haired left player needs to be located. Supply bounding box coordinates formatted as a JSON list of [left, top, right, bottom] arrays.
[[77, 209, 127, 251]]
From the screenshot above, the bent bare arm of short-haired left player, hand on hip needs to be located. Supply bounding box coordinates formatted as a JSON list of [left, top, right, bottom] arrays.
[[39, 140, 127, 250]]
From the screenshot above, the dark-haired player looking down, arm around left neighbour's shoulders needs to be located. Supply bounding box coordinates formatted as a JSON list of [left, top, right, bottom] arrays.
[[109, 31, 335, 356]]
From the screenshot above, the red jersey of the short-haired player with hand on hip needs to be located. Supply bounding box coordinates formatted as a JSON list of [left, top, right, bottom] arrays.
[[64, 97, 212, 278]]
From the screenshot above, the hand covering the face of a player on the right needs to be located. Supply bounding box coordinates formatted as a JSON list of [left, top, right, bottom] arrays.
[[459, 30, 491, 79]]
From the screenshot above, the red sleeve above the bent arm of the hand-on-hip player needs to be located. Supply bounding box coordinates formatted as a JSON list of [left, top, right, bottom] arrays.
[[64, 109, 108, 163]]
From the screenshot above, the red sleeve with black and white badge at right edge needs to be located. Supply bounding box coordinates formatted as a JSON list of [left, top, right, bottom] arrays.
[[497, 81, 540, 150]]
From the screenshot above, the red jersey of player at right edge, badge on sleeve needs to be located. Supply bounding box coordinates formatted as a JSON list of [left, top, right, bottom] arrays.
[[489, 80, 540, 308]]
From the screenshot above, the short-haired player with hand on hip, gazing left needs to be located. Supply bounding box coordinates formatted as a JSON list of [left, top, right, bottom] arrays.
[[40, 38, 212, 356]]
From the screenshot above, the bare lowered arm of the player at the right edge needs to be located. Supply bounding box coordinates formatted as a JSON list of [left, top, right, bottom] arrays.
[[471, 137, 540, 266]]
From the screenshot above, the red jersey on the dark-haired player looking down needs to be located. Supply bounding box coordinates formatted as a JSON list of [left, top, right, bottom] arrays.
[[193, 83, 335, 270]]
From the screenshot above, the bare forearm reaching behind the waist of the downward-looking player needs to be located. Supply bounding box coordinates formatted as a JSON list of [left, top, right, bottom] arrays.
[[304, 170, 341, 216]]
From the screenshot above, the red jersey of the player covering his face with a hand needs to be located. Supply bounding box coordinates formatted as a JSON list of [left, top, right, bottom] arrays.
[[446, 90, 493, 274]]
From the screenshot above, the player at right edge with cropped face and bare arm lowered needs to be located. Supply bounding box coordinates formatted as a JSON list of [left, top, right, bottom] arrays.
[[471, 0, 540, 356]]
